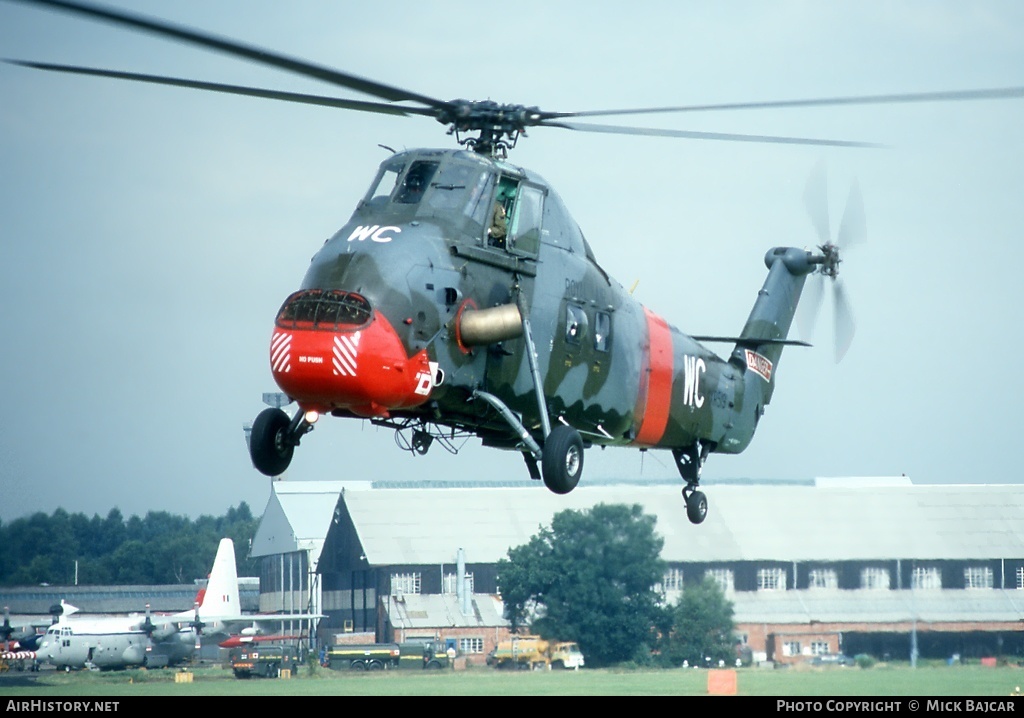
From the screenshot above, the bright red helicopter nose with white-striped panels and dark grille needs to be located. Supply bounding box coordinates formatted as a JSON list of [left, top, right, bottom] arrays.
[[270, 290, 434, 417]]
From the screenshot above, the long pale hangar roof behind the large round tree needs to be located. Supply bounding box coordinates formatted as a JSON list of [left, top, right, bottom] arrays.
[[339, 481, 1024, 565]]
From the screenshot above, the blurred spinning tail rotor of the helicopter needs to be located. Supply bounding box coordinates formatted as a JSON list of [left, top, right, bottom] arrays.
[[797, 162, 866, 364]]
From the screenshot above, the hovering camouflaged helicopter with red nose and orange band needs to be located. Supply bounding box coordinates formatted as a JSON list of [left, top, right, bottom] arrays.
[[8, 0, 1024, 523]]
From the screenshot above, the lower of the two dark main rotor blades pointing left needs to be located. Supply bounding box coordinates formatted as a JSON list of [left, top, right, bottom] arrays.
[[3, 59, 434, 117]]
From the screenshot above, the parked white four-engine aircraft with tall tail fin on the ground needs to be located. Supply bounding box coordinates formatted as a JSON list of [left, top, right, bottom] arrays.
[[36, 539, 321, 670]]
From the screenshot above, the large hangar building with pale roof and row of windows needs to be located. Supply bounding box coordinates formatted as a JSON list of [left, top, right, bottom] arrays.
[[262, 477, 1024, 663]]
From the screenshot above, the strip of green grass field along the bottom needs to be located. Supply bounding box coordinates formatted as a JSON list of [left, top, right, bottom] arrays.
[[0, 665, 1024, 696]]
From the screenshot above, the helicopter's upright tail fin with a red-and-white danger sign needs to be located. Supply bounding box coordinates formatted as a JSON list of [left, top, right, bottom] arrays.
[[730, 247, 820, 407]]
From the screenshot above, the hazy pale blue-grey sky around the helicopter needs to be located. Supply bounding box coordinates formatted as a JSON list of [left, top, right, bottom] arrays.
[[0, 0, 1024, 521]]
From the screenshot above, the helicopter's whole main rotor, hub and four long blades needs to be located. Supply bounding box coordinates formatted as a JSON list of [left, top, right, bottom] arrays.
[[4, 0, 1024, 155]]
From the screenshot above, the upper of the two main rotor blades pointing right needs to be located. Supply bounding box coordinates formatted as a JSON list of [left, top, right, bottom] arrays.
[[546, 87, 1024, 119]]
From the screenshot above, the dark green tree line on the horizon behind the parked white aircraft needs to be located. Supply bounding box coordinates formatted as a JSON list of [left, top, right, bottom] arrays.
[[0, 502, 259, 586]]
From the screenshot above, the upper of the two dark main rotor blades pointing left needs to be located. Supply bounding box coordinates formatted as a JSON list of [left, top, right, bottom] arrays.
[[10, 0, 450, 110]]
